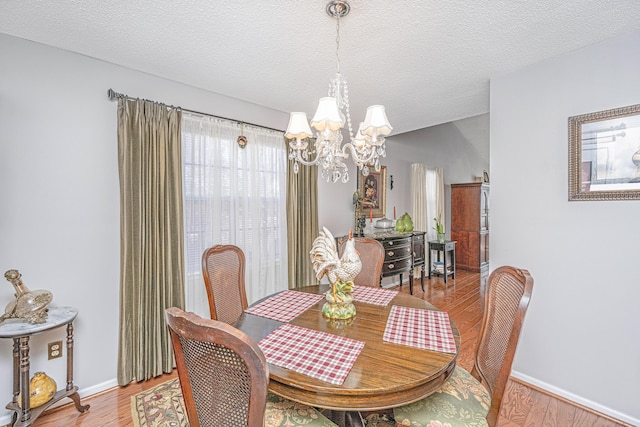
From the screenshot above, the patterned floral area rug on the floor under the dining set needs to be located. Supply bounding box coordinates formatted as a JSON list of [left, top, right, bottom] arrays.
[[131, 378, 396, 427]]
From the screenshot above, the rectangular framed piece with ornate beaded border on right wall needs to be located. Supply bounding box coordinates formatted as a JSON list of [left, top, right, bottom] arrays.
[[569, 104, 640, 201]]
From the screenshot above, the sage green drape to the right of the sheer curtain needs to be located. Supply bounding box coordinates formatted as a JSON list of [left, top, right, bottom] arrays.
[[287, 148, 319, 289]]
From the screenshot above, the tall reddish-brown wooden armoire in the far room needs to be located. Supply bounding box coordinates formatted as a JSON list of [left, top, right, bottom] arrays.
[[451, 182, 489, 279]]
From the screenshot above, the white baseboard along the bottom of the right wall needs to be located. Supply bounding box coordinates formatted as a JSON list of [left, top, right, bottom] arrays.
[[511, 371, 640, 427]]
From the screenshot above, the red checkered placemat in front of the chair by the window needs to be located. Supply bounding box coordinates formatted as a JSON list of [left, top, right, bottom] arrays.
[[245, 290, 324, 322]]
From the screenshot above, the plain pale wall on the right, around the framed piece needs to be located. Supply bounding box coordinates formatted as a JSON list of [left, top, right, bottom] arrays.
[[491, 32, 640, 425]]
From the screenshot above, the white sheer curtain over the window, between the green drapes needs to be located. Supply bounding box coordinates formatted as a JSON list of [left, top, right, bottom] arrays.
[[182, 112, 287, 317]]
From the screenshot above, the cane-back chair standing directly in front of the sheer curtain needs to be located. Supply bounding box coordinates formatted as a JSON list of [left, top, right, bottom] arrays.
[[202, 245, 248, 325]]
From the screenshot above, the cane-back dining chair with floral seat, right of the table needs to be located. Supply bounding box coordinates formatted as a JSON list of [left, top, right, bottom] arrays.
[[393, 266, 533, 427]]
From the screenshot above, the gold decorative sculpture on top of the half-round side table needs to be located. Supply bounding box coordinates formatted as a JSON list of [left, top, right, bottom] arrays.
[[0, 270, 53, 323]]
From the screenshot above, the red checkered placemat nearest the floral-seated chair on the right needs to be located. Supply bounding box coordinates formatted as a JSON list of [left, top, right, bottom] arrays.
[[382, 305, 456, 353]]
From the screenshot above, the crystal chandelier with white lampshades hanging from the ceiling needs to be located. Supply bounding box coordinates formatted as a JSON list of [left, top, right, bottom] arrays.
[[285, 0, 393, 183]]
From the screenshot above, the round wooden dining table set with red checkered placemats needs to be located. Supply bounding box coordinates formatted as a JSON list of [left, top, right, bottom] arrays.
[[235, 284, 460, 426]]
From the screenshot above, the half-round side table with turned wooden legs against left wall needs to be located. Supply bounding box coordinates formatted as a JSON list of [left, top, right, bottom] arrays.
[[0, 307, 89, 427]]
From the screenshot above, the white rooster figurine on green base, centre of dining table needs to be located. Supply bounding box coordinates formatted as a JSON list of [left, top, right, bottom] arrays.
[[310, 227, 362, 319]]
